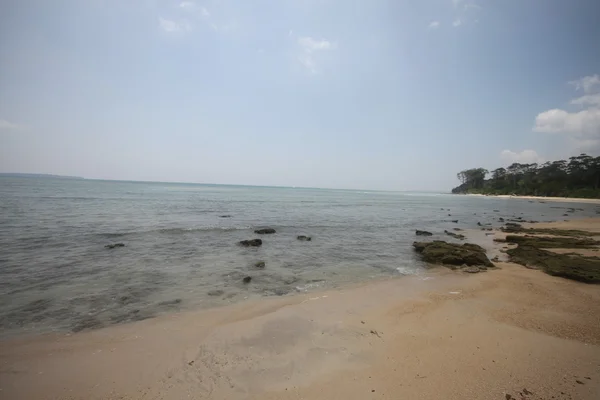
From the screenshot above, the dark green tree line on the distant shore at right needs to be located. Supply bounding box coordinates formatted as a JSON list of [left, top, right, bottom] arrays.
[[452, 154, 600, 198]]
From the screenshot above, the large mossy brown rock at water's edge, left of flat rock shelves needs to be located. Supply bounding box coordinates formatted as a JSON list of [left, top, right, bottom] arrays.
[[413, 240, 494, 268]]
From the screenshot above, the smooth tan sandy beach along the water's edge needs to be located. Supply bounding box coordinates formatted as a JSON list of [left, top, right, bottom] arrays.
[[0, 219, 600, 400]]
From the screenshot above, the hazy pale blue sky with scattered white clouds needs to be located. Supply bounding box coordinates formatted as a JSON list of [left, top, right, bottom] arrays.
[[0, 0, 600, 191]]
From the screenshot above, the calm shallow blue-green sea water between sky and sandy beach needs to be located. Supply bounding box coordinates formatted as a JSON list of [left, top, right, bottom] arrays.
[[0, 176, 597, 337]]
